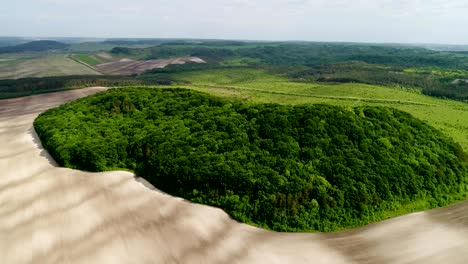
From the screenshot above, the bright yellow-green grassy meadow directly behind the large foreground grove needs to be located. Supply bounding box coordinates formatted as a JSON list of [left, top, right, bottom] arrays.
[[170, 68, 468, 151]]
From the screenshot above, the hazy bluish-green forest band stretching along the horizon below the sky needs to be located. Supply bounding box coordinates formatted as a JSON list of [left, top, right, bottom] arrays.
[[112, 42, 468, 69]]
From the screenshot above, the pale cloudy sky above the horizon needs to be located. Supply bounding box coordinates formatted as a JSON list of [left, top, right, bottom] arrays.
[[0, 0, 468, 44]]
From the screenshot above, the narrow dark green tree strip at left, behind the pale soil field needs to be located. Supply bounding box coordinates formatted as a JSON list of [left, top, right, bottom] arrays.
[[0, 76, 172, 99]]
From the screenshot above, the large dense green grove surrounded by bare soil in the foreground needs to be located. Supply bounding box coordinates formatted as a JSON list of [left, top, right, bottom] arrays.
[[34, 88, 468, 231]]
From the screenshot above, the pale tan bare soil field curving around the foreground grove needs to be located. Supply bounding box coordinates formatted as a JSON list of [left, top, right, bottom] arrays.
[[0, 88, 468, 263]]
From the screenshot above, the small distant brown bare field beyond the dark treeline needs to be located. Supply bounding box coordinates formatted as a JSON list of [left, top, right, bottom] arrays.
[[94, 57, 205, 75]]
